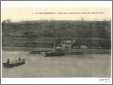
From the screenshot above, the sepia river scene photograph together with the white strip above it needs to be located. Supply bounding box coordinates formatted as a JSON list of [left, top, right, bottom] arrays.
[[1, 1, 112, 84]]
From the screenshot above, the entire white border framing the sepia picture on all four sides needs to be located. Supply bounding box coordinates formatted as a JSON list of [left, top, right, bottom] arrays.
[[1, 1, 112, 84]]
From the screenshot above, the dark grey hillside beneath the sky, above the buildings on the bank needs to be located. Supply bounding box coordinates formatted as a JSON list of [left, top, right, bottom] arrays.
[[2, 20, 111, 48]]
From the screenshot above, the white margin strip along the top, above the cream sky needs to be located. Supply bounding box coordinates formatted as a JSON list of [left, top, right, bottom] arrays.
[[1, 1, 112, 7]]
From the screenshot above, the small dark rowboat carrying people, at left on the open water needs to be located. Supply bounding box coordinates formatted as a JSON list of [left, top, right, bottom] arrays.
[[3, 58, 25, 68]]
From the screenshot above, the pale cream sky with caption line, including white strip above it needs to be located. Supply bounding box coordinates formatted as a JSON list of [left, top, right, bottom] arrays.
[[1, 2, 112, 21]]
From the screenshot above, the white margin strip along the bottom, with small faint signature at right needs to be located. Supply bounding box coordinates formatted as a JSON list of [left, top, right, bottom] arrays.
[[2, 78, 112, 84]]
